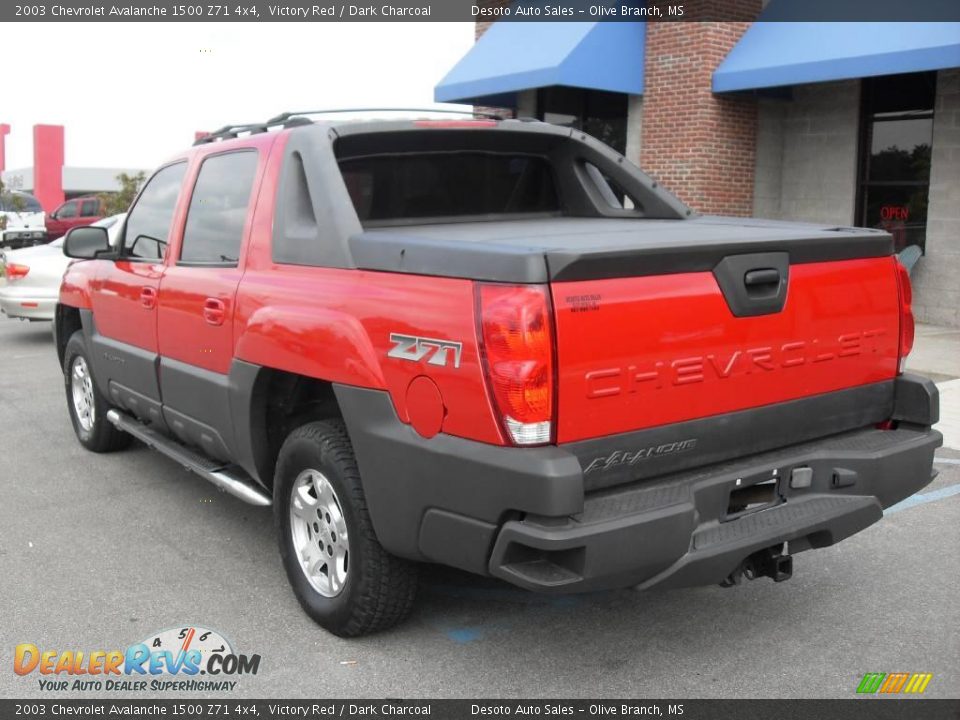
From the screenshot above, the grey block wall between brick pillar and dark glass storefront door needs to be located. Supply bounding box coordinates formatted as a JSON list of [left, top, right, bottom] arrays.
[[754, 80, 860, 225]]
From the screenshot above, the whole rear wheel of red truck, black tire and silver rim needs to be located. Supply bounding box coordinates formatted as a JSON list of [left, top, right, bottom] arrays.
[[274, 420, 417, 637]]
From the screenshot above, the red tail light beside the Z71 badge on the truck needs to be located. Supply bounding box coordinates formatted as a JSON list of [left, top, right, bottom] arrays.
[[476, 284, 555, 445]]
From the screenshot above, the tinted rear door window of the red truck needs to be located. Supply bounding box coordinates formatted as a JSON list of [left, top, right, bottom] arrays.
[[180, 151, 257, 265]]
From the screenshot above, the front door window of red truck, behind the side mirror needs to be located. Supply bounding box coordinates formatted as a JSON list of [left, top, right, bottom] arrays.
[[121, 162, 187, 260]]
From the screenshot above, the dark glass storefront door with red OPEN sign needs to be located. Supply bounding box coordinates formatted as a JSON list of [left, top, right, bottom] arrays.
[[857, 73, 936, 251]]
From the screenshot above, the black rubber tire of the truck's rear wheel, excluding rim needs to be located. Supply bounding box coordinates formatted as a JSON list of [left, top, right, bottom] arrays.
[[274, 420, 417, 637]]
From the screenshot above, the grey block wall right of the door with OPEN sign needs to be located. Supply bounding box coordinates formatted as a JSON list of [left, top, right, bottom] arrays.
[[911, 69, 960, 327]]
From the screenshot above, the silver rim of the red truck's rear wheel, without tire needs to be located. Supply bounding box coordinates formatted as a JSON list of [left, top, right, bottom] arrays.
[[290, 469, 350, 597]]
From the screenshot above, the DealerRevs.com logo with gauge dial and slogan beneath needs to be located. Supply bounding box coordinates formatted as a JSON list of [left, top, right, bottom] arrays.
[[13, 626, 260, 692]]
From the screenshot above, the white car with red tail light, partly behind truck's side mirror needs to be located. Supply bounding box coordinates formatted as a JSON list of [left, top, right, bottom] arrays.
[[0, 214, 126, 320]]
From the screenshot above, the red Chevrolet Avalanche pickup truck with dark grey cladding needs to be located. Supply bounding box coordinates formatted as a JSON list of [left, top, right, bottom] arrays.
[[56, 114, 941, 636]]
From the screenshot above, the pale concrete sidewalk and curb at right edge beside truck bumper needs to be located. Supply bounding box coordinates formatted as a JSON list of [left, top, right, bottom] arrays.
[[907, 325, 960, 450]]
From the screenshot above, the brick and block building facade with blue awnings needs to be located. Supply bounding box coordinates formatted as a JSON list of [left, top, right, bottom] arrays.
[[435, 11, 960, 327]]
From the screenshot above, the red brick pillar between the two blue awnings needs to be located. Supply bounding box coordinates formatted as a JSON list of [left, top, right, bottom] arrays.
[[640, 14, 761, 216]]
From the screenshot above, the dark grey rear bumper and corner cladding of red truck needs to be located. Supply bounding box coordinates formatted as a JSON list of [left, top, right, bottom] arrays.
[[336, 376, 942, 592]]
